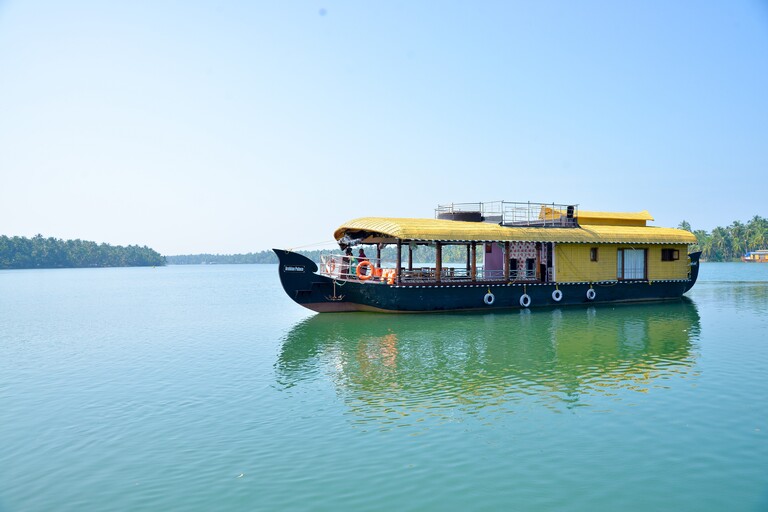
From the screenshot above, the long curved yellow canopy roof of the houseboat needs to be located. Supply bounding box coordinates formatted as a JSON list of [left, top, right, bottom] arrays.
[[334, 217, 696, 244]]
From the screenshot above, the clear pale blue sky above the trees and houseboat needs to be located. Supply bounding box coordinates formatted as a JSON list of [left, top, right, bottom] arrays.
[[0, 0, 768, 255]]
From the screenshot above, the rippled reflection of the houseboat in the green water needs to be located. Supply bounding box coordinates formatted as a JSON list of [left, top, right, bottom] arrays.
[[276, 298, 700, 423]]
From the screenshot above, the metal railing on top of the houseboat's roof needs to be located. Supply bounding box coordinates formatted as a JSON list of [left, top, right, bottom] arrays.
[[435, 201, 579, 227]]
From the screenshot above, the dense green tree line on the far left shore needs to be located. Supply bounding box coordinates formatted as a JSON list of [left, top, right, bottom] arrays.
[[0, 235, 166, 269]]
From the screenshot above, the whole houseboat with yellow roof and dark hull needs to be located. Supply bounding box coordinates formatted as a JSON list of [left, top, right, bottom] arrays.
[[274, 201, 701, 313]]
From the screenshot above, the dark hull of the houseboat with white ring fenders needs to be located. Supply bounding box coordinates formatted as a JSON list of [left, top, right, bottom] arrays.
[[275, 249, 699, 313]]
